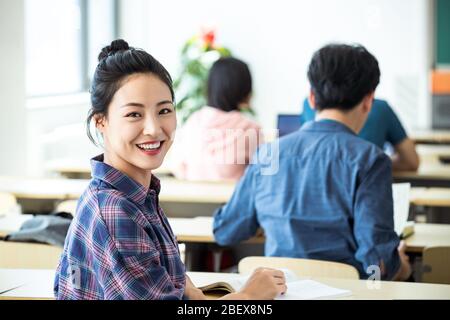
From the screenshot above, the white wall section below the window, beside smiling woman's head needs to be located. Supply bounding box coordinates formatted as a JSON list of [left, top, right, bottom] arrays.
[[27, 97, 102, 176]]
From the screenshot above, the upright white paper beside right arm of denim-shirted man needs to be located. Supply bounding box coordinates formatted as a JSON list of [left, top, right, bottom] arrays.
[[392, 183, 411, 236]]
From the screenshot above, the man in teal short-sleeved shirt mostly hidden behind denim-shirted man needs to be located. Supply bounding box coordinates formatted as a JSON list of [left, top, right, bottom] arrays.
[[300, 99, 419, 171]]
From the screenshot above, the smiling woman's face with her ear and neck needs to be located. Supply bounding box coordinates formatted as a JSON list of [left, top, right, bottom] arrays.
[[94, 73, 177, 186]]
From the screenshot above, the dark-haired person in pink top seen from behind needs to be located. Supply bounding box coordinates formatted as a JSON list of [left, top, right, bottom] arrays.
[[173, 58, 263, 180]]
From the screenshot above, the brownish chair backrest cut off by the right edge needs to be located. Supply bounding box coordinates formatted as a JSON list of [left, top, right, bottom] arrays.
[[422, 247, 450, 284]]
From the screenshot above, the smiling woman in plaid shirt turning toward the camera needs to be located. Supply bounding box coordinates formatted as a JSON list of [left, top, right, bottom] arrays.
[[54, 40, 286, 299]]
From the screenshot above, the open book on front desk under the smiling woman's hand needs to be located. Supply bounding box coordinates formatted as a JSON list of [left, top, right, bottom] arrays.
[[193, 269, 352, 300]]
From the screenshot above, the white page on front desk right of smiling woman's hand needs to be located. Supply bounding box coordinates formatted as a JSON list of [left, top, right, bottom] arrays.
[[275, 279, 352, 300]]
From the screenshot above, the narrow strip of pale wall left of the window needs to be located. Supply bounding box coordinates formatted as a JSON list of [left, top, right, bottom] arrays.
[[0, 0, 27, 175]]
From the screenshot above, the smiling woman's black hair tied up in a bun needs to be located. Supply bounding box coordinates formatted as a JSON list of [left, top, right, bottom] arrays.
[[86, 39, 175, 145]]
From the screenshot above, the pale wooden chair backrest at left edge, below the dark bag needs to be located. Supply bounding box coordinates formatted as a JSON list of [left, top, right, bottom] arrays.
[[0, 241, 62, 269]]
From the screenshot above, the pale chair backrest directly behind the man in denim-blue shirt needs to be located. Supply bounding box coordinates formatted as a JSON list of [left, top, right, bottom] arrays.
[[238, 257, 359, 279]]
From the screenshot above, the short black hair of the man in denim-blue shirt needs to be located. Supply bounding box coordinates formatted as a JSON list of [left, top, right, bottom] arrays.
[[308, 44, 380, 111]]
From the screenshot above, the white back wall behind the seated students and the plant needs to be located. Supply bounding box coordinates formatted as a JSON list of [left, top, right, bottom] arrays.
[[122, 0, 432, 129]]
